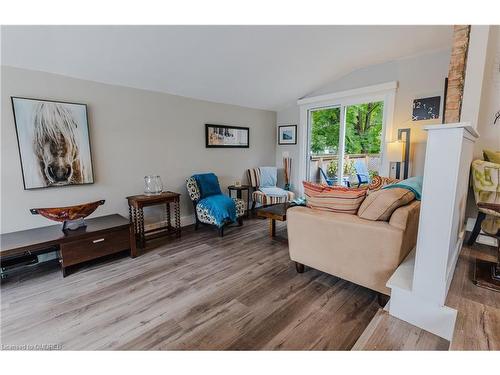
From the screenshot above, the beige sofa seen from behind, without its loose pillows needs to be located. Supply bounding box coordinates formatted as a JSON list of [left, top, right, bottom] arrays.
[[287, 201, 420, 295]]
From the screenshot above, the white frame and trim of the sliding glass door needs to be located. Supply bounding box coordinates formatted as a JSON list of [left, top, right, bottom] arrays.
[[297, 81, 398, 195]]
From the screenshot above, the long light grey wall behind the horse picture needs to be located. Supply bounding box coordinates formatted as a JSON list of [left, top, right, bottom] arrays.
[[0, 66, 276, 233]]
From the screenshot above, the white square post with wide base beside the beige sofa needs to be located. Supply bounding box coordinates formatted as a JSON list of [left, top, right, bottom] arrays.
[[387, 123, 478, 340]]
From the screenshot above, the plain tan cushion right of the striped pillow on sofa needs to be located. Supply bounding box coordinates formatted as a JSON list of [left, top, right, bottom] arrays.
[[358, 188, 415, 221]]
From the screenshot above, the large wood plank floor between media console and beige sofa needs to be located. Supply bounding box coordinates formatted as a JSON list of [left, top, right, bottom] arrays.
[[1, 219, 378, 350]]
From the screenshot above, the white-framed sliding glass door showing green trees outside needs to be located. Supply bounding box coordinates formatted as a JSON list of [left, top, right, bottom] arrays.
[[299, 82, 397, 186]]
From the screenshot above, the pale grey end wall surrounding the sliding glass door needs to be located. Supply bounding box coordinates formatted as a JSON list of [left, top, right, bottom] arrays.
[[276, 50, 450, 192]]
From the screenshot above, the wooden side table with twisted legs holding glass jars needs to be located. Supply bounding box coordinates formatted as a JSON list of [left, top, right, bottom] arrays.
[[127, 191, 181, 248]]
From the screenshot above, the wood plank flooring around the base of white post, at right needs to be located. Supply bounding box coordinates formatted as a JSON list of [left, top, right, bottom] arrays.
[[353, 239, 500, 350]]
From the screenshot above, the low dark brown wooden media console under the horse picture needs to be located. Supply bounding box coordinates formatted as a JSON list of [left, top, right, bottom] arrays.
[[0, 214, 137, 276]]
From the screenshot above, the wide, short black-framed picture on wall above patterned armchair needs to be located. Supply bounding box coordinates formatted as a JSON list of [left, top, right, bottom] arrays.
[[205, 124, 250, 148]]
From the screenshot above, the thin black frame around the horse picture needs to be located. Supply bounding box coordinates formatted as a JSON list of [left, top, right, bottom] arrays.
[[10, 96, 95, 190]]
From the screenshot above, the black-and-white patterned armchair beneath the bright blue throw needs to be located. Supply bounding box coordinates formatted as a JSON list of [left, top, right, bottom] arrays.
[[186, 176, 246, 237]]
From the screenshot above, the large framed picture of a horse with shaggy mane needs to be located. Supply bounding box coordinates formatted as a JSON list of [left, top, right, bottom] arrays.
[[11, 97, 94, 190]]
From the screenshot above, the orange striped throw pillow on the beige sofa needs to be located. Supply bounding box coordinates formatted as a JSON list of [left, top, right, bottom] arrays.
[[303, 181, 366, 215]]
